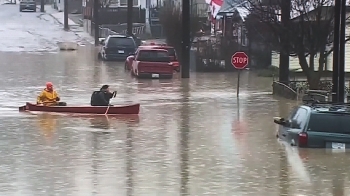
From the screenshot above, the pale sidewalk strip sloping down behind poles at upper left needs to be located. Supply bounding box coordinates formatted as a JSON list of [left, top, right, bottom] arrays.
[[39, 5, 95, 44]]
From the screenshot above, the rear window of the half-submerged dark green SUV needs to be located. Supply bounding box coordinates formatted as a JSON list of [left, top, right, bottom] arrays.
[[308, 113, 350, 134]]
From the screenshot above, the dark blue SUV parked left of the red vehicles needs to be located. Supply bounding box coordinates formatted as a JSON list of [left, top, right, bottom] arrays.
[[98, 35, 137, 60]]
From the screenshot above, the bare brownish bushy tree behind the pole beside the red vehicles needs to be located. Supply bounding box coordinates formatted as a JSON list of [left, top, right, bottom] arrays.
[[159, 4, 201, 66]]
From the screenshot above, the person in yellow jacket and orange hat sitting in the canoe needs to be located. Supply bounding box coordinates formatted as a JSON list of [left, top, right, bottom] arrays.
[[36, 82, 66, 106]]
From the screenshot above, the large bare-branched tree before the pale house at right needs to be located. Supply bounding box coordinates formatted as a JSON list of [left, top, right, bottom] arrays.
[[247, 0, 349, 89]]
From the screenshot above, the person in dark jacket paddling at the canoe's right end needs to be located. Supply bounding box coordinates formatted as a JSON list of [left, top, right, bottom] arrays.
[[90, 85, 117, 106]]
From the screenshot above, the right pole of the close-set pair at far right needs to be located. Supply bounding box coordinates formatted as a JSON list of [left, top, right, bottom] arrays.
[[338, 0, 346, 103]]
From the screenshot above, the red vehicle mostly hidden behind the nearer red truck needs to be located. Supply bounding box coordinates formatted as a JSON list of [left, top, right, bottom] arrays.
[[125, 44, 180, 72]]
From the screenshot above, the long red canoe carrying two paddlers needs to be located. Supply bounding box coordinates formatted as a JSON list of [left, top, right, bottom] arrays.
[[19, 102, 140, 115]]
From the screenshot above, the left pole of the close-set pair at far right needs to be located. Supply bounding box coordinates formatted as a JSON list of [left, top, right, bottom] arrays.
[[332, 0, 341, 102]]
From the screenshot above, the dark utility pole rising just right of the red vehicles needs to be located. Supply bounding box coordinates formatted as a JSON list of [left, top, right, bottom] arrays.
[[181, 0, 191, 78]]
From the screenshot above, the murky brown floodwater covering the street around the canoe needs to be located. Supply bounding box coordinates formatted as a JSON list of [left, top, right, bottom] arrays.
[[0, 47, 350, 196]]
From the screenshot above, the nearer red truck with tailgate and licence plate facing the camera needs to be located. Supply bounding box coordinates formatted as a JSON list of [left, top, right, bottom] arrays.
[[128, 49, 174, 79]]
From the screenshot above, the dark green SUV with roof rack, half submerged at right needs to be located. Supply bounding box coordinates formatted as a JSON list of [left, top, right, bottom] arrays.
[[274, 103, 350, 150]]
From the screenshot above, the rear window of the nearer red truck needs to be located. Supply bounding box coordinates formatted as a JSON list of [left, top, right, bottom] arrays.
[[137, 50, 170, 62]]
